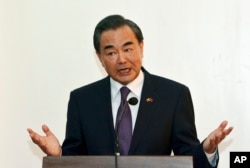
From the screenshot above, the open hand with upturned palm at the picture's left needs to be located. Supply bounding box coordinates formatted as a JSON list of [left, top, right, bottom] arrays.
[[27, 125, 61, 156]]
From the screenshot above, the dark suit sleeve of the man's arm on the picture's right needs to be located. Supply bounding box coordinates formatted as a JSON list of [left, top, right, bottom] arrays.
[[173, 87, 217, 168]]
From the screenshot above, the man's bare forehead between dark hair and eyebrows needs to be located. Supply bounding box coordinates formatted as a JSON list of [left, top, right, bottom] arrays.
[[100, 26, 137, 49]]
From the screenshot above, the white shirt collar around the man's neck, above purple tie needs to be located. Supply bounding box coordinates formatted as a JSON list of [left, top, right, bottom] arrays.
[[110, 70, 144, 99]]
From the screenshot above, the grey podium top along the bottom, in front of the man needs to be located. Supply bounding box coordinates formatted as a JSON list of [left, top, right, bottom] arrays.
[[42, 155, 193, 168]]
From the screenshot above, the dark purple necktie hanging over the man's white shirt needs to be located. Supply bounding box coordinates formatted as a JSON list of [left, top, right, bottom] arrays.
[[116, 87, 132, 155]]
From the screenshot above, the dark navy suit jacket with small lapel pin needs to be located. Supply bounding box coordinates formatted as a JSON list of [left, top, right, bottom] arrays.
[[62, 68, 218, 168]]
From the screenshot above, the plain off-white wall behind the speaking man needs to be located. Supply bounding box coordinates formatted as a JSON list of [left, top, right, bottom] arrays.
[[0, 0, 250, 168]]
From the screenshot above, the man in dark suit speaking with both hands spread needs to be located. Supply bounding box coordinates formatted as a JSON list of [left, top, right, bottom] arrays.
[[28, 15, 233, 168]]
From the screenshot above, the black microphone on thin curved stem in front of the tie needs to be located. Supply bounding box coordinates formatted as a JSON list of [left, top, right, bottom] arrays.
[[115, 97, 138, 156]]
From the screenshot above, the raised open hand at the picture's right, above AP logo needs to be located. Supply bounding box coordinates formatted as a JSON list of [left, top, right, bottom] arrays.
[[203, 121, 233, 154]]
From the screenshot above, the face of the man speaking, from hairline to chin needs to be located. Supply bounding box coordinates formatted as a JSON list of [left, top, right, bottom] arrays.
[[97, 26, 143, 85]]
